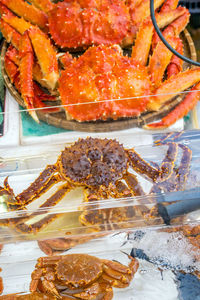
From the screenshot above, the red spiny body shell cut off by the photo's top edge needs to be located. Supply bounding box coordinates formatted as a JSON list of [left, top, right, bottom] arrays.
[[48, 0, 130, 48]]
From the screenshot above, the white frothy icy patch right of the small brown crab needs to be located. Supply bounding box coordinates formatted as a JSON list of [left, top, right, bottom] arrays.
[[129, 230, 200, 272]]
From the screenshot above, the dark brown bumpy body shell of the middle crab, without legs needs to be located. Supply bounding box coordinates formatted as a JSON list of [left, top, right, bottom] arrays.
[[58, 138, 128, 187]]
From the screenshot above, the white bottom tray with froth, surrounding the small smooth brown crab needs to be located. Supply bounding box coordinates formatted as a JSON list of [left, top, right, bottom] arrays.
[[0, 223, 200, 300]]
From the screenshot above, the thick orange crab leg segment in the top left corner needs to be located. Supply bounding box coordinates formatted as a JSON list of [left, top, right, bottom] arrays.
[[0, 0, 47, 29]]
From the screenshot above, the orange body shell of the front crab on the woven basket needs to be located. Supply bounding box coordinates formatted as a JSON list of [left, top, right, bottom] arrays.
[[59, 45, 152, 121]]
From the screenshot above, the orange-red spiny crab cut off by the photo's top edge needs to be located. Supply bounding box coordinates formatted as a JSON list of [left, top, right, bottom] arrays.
[[0, 0, 184, 49]]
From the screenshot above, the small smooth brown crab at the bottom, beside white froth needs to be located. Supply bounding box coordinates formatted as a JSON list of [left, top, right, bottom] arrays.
[[30, 254, 139, 300]]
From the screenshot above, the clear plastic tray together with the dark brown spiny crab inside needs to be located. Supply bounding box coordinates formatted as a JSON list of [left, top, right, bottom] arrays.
[[0, 131, 200, 243]]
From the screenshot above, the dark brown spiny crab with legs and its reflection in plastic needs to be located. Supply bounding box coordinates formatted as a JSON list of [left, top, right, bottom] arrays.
[[0, 138, 192, 233]]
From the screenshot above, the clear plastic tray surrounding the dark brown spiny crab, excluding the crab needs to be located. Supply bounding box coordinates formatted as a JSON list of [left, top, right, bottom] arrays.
[[0, 131, 200, 243]]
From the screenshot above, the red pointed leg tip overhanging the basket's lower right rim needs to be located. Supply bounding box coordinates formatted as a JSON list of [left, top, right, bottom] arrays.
[[144, 83, 200, 129]]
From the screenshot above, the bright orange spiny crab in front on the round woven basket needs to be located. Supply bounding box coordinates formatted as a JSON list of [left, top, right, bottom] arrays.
[[0, 0, 200, 129]]
